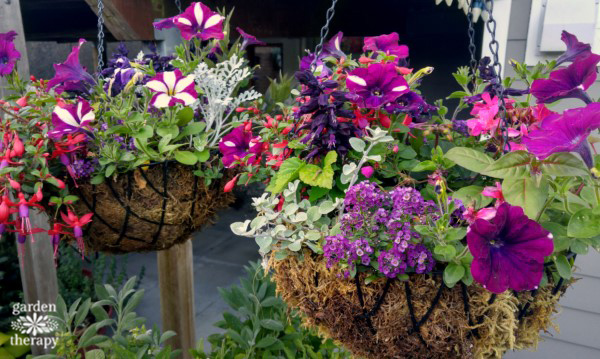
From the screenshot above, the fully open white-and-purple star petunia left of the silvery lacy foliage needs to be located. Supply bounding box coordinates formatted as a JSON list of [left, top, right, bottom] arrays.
[[146, 69, 198, 108]]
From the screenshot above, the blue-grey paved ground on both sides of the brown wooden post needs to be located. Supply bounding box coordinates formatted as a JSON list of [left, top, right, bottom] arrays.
[[122, 197, 260, 346]]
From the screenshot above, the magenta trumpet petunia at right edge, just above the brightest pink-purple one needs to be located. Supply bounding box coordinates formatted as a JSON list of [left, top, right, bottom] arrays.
[[531, 54, 600, 103]]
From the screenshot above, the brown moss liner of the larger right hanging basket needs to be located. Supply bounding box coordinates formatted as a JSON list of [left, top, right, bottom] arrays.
[[269, 253, 564, 359]]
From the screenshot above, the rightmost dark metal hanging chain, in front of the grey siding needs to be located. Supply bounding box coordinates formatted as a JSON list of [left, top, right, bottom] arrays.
[[483, 0, 510, 153]]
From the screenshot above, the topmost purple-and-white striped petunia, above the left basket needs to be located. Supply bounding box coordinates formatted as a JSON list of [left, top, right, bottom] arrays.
[[154, 2, 225, 41]]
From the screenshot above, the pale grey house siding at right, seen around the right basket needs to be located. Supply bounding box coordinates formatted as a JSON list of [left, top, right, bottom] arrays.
[[501, 0, 600, 359]]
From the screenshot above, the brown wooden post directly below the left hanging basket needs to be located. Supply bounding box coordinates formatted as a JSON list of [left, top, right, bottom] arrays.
[[157, 239, 196, 359]]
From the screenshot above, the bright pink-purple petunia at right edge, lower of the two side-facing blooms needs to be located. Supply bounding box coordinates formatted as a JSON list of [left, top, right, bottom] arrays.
[[522, 102, 600, 168]]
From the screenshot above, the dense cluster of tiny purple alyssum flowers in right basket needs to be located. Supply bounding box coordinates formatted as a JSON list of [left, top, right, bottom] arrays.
[[323, 181, 436, 278]]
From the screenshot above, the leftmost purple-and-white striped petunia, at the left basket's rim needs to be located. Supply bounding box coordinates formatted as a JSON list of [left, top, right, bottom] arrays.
[[48, 98, 96, 139]]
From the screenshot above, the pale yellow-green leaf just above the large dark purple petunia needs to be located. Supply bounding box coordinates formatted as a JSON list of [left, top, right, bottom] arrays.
[[502, 176, 549, 219]]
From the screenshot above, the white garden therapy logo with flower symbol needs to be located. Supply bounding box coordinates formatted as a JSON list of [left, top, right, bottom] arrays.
[[10, 301, 58, 348]]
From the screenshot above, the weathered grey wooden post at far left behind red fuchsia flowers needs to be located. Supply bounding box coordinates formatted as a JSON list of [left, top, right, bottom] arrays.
[[0, 0, 58, 355]]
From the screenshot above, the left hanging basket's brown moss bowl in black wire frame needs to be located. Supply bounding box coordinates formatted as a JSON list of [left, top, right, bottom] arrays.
[[75, 162, 234, 253]]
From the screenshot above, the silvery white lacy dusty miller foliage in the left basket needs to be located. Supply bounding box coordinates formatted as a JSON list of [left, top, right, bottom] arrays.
[[194, 55, 262, 146]]
